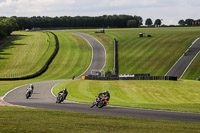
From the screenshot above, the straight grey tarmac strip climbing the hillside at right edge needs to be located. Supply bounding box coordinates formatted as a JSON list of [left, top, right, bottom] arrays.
[[165, 38, 200, 79]]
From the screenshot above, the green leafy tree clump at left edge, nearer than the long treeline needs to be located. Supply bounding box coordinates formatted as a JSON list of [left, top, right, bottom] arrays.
[[0, 17, 18, 38]]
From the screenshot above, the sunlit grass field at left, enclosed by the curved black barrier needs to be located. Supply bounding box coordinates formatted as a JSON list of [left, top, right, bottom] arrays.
[[0, 32, 55, 78]]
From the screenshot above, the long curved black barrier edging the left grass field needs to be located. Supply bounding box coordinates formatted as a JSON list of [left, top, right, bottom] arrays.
[[0, 32, 59, 81]]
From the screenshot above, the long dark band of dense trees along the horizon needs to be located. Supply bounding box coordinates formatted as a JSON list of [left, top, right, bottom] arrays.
[[0, 15, 143, 29]]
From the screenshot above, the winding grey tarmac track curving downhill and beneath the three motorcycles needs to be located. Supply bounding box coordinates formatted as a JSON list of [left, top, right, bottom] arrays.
[[3, 32, 200, 122]]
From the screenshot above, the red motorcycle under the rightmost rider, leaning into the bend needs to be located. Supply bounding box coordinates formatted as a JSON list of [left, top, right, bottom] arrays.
[[90, 96, 109, 108]]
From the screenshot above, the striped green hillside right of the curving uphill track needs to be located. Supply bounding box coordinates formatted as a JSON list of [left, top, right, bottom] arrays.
[[71, 27, 200, 79]]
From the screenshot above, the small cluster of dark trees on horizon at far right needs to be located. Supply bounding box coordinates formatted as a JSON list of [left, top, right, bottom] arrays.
[[178, 18, 200, 26]]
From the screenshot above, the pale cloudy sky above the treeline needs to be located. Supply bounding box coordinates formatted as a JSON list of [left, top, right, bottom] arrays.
[[0, 0, 200, 25]]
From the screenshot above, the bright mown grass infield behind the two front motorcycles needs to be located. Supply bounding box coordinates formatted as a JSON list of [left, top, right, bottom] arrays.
[[53, 80, 200, 113]]
